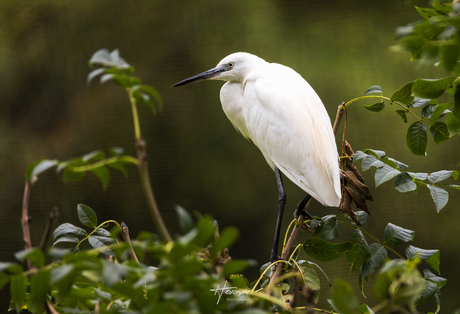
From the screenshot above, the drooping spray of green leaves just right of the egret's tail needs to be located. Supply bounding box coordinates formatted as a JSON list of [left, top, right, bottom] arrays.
[[353, 149, 460, 212]]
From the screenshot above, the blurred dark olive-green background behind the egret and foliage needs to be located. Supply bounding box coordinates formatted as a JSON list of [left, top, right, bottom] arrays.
[[0, 0, 460, 313]]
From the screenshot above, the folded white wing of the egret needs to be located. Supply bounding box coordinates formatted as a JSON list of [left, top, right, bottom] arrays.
[[243, 63, 340, 206]]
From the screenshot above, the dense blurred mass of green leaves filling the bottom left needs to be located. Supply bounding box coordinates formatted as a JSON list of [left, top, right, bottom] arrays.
[[0, 205, 268, 313]]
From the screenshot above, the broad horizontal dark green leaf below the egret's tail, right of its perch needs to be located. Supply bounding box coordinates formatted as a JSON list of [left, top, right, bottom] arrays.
[[303, 239, 353, 262]]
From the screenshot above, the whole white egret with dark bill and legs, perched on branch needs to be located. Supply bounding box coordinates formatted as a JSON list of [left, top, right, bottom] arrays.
[[173, 52, 341, 261]]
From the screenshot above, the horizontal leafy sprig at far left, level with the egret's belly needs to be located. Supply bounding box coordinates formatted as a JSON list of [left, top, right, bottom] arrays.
[[25, 147, 138, 189]]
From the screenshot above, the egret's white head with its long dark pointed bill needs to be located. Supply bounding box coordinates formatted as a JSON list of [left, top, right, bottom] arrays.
[[172, 52, 267, 87]]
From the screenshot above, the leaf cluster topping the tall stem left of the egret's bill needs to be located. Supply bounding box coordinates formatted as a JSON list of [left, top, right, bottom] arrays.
[[87, 49, 162, 113]]
